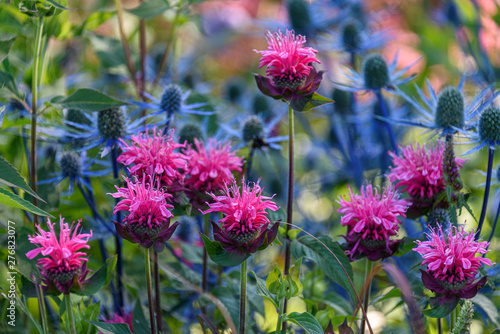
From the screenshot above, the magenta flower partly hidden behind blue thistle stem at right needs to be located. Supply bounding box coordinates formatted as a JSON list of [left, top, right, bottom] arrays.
[[389, 143, 464, 217]]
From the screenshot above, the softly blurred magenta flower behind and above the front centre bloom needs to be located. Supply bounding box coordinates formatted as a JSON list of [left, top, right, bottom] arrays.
[[184, 138, 243, 208]]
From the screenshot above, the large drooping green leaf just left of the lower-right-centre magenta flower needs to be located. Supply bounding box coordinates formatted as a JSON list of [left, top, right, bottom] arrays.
[[291, 235, 357, 303]]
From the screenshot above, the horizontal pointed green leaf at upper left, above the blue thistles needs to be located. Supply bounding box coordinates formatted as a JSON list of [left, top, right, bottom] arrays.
[[51, 88, 127, 111]]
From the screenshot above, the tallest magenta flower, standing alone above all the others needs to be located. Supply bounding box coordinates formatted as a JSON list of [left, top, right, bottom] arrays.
[[254, 30, 323, 110]]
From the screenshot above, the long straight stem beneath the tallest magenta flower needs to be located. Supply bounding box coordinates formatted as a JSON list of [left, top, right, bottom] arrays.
[[283, 107, 295, 329]]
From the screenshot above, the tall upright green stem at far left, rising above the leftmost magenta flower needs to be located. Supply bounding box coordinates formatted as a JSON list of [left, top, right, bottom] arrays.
[[30, 16, 44, 224]]
